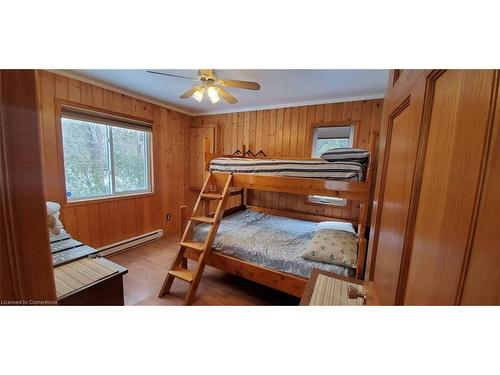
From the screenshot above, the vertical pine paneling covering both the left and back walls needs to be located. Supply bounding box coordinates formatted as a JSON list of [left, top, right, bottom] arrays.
[[37, 71, 383, 247]]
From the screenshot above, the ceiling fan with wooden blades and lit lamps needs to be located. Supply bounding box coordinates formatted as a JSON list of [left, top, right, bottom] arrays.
[[147, 69, 260, 104]]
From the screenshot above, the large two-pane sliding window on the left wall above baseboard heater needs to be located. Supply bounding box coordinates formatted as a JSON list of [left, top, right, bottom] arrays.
[[61, 108, 152, 201]]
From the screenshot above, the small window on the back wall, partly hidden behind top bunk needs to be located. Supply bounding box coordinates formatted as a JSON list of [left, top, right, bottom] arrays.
[[308, 125, 354, 206]]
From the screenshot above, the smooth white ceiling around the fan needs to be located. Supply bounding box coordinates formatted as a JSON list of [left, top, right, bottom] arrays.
[[59, 69, 388, 115]]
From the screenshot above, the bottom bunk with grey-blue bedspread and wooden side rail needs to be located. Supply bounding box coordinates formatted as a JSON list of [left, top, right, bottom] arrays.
[[186, 209, 356, 297]]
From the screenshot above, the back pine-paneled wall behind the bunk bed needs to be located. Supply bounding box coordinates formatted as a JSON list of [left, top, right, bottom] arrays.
[[188, 99, 383, 220]]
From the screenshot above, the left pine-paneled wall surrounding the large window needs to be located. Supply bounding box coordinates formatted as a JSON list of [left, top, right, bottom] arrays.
[[37, 71, 192, 247]]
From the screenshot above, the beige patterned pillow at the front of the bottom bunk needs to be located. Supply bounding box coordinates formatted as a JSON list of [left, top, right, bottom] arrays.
[[302, 229, 358, 268]]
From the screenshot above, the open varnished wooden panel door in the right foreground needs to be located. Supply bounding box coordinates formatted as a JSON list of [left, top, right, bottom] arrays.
[[370, 70, 500, 305]]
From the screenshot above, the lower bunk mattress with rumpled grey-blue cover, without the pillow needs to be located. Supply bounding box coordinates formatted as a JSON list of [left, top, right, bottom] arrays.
[[193, 210, 355, 278]]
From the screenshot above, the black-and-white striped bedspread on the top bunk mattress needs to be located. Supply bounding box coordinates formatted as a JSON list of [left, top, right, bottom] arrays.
[[210, 158, 364, 181]]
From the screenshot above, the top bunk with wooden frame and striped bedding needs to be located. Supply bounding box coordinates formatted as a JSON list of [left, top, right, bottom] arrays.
[[204, 134, 376, 201]]
